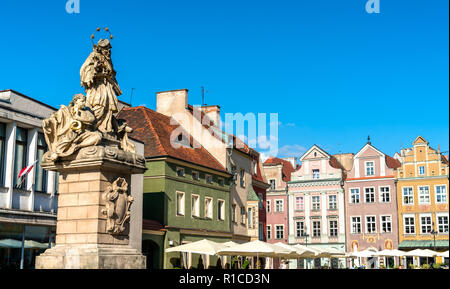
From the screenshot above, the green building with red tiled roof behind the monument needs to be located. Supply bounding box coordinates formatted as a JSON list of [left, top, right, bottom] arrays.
[[119, 107, 232, 268]]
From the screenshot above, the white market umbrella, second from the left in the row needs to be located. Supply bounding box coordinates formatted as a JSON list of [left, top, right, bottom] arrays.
[[217, 240, 292, 257]]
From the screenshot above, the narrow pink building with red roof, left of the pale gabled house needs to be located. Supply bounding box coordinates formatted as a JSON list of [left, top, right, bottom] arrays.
[[263, 157, 295, 244]]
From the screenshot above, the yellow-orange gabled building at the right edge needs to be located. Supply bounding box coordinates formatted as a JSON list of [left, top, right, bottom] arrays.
[[395, 136, 449, 251]]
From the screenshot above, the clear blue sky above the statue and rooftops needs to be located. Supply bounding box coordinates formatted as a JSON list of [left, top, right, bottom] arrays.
[[0, 0, 449, 156]]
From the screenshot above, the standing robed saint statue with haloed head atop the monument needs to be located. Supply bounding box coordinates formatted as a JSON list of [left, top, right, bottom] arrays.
[[80, 39, 122, 135]]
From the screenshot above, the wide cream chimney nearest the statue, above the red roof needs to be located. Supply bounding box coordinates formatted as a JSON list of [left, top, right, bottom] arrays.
[[156, 89, 188, 117]]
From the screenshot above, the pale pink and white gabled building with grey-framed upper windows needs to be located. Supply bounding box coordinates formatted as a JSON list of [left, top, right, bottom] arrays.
[[288, 145, 346, 268]]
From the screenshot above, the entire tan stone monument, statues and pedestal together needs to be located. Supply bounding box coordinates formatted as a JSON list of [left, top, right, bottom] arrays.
[[36, 30, 146, 269]]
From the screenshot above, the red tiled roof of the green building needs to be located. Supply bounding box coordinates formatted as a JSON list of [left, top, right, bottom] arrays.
[[118, 106, 226, 172]]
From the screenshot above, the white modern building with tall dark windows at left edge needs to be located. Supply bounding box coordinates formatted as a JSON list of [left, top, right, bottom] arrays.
[[0, 90, 57, 269]]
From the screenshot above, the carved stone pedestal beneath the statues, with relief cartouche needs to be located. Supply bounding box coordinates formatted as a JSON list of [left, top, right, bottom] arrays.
[[36, 146, 146, 269]]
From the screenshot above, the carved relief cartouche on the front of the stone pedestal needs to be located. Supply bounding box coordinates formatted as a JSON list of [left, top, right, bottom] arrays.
[[102, 178, 133, 234]]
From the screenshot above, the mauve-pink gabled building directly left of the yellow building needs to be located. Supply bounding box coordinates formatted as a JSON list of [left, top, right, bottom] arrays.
[[344, 139, 400, 266]]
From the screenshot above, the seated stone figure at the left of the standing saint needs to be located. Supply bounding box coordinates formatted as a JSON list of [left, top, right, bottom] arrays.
[[43, 94, 102, 161]]
